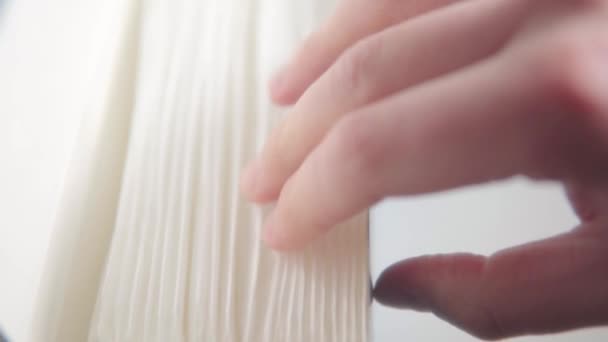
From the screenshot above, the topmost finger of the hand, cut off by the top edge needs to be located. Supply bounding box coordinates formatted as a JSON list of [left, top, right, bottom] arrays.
[[270, 0, 458, 104]]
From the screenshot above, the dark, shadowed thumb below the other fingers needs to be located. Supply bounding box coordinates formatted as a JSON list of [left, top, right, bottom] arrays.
[[374, 226, 608, 339]]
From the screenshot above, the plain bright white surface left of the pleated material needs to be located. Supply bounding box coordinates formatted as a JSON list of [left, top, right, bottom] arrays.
[[0, 0, 111, 341]]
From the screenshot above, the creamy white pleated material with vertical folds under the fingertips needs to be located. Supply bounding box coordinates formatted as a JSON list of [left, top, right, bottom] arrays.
[[27, 0, 370, 342]]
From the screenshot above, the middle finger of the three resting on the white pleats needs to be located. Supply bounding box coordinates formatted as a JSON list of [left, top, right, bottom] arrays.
[[244, 1, 526, 201]]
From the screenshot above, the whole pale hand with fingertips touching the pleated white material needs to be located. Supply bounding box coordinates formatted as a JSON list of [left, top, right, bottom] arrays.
[[242, 0, 608, 339]]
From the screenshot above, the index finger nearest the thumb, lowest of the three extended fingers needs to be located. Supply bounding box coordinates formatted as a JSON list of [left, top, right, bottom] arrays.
[[264, 26, 608, 249]]
